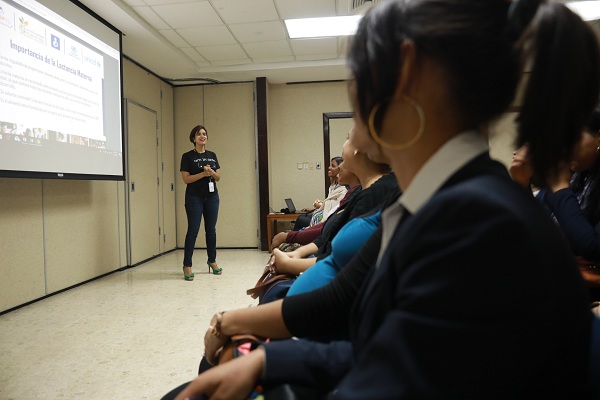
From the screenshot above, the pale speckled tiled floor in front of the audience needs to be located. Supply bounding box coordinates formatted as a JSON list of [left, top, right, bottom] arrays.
[[0, 250, 268, 400]]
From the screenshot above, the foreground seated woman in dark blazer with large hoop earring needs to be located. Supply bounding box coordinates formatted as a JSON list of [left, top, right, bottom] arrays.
[[166, 0, 600, 400]]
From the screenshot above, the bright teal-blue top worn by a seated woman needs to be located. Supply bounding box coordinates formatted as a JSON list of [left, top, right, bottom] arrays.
[[287, 211, 381, 296]]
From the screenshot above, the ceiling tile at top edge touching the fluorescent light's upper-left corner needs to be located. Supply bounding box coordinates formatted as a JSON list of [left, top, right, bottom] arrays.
[[212, 0, 279, 24]]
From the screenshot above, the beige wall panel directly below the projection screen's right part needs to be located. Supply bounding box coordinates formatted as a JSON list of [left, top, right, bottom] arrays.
[[44, 180, 121, 293]]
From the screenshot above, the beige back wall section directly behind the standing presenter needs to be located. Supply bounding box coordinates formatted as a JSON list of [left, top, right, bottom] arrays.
[[174, 83, 258, 248]]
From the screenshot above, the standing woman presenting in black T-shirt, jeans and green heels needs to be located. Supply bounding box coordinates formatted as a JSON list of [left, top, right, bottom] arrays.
[[179, 125, 223, 281]]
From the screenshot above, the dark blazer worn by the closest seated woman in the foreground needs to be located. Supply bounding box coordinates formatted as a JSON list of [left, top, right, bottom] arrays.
[[335, 154, 591, 399]]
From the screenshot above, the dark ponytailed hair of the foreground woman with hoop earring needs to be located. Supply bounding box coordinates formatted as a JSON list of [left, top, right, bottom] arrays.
[[348, 0, 600, 181]]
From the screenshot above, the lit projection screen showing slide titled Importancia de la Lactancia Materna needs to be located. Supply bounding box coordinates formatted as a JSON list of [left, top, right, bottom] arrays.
[[0, 0, 124, 179]]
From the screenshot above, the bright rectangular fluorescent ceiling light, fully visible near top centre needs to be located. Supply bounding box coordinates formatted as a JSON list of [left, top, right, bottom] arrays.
[[285, 15, 362, 39]]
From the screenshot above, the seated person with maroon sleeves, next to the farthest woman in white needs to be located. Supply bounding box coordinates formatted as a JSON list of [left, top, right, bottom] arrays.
[[269, 170, 361, 251]]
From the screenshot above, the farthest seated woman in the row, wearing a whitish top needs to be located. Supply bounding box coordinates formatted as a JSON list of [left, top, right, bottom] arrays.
[[294, 157, 348, 230]]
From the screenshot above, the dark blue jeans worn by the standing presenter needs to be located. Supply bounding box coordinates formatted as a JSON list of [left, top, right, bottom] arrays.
[[183, 194, 219, 267]]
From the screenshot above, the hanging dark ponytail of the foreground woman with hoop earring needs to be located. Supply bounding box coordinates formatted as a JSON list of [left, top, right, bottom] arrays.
[[509, 0, 600, 182]]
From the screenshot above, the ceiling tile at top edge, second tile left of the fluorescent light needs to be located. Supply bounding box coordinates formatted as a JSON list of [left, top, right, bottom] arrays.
[[152, 2, 223, 29]]
